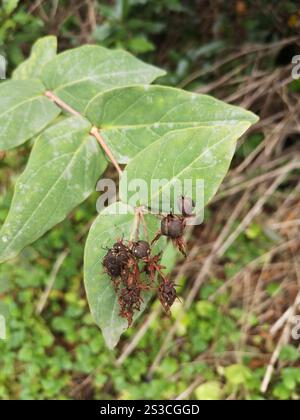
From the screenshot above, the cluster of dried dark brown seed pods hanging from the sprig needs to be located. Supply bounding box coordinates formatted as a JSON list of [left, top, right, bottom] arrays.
[[103, 208, 191, 326]]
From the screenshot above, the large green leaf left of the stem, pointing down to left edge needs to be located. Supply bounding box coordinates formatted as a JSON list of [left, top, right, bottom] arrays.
[[0, 117, 107, 262]]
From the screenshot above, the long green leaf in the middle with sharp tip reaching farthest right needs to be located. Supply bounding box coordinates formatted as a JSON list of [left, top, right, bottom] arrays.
[[85, 86, 258, 163]]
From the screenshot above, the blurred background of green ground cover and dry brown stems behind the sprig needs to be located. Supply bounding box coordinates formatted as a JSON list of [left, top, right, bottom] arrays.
[[0, 0, 300, 400]]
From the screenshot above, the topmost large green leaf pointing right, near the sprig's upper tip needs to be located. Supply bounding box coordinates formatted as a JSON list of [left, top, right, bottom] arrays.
[[43, 45, 165, 112]]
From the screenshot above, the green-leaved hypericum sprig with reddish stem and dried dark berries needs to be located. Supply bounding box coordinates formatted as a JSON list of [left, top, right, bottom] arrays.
[[0, 36, 257, 348]]
